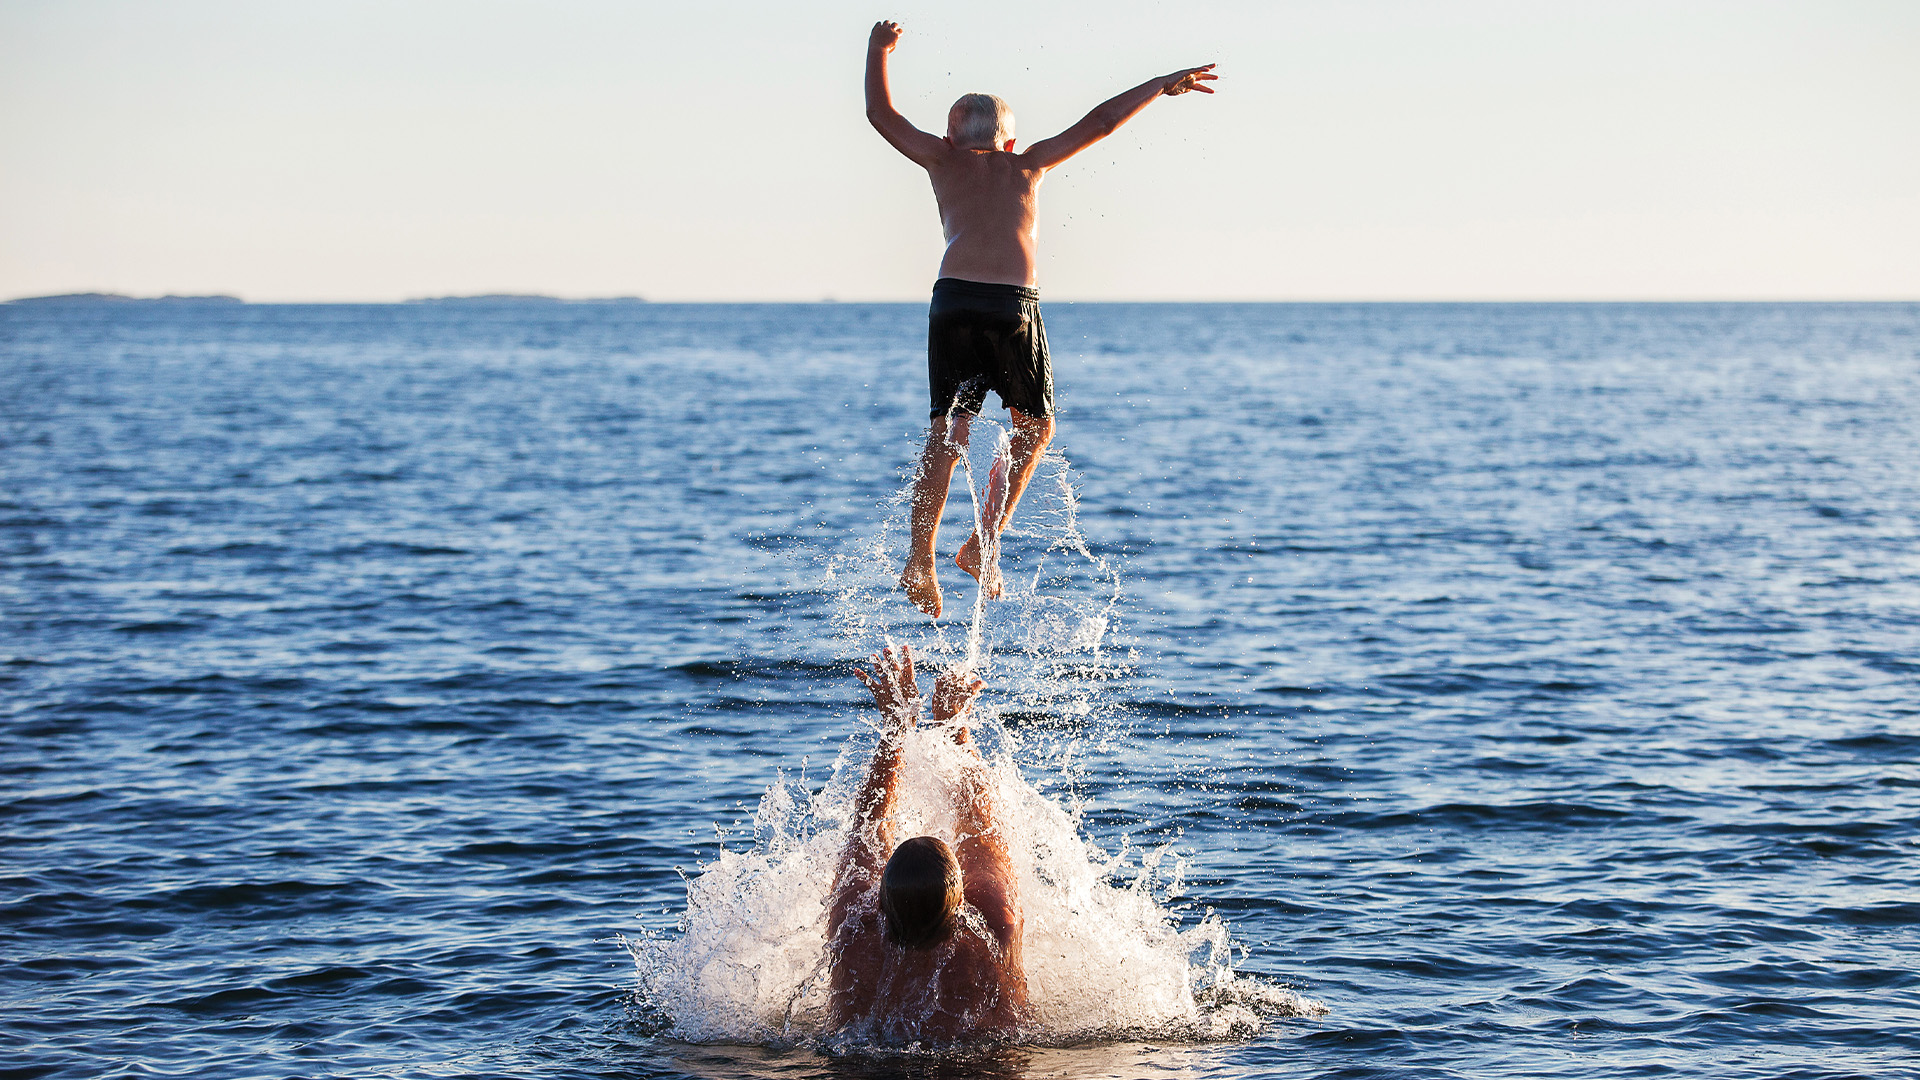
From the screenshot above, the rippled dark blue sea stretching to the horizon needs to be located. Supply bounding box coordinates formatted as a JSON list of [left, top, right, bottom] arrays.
[[0, 302, 1920, 1078]]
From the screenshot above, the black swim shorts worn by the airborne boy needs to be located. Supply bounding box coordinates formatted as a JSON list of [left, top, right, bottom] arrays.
[[927, 277, 1054, 417]]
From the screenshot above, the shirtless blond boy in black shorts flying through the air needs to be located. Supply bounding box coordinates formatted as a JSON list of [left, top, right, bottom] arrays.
[[866, 21, 1215, 617]]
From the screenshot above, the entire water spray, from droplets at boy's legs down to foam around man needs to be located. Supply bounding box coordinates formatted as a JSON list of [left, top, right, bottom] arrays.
[[630, 421, 1325, 1045]]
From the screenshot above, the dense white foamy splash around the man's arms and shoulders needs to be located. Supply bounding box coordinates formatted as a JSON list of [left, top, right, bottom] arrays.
[[630, 728, 1323, 1045]]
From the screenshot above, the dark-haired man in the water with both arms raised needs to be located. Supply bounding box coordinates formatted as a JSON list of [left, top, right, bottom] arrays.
[[828, 648, 1027, 1043]]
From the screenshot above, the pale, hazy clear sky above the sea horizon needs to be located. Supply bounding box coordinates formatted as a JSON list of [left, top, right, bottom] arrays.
[[0, 0, 1920, 302]]
